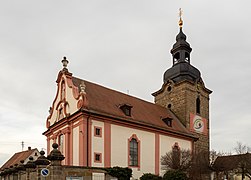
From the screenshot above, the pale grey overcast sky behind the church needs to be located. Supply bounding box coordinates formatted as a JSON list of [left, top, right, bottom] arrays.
[[0, 0, 251, 165]]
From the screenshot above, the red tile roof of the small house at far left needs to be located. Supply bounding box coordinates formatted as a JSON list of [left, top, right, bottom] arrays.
[[0, 148, 38, 170]]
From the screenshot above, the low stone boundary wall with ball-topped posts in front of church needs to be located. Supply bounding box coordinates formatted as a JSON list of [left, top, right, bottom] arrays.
[[0, 144, 114, 180]]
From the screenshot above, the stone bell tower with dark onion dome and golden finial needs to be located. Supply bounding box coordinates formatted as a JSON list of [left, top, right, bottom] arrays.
[[152, 11, 212, 152]]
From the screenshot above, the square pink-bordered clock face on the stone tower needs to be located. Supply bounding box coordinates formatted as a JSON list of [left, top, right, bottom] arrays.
[[190, 113, 207, 134]]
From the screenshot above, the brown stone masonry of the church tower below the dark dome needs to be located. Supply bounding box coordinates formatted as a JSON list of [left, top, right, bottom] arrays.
[[154, 80, 211, 151]]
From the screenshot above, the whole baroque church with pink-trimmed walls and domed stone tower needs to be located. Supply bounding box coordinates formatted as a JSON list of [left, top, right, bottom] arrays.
[[43, 20, 212, 178]]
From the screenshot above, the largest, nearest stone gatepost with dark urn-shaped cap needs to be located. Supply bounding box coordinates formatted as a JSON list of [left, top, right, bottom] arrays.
[[47, 143, 65, 180]]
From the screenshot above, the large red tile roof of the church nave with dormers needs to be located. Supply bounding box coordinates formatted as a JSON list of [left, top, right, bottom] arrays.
[[72, 77, 194, 137]]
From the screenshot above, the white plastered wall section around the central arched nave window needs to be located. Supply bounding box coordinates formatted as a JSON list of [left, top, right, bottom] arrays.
[[111, 125, 155, 178]]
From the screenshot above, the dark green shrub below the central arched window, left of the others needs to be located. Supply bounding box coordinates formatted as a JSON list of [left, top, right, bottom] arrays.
[[106, 166, 132, 180]]
